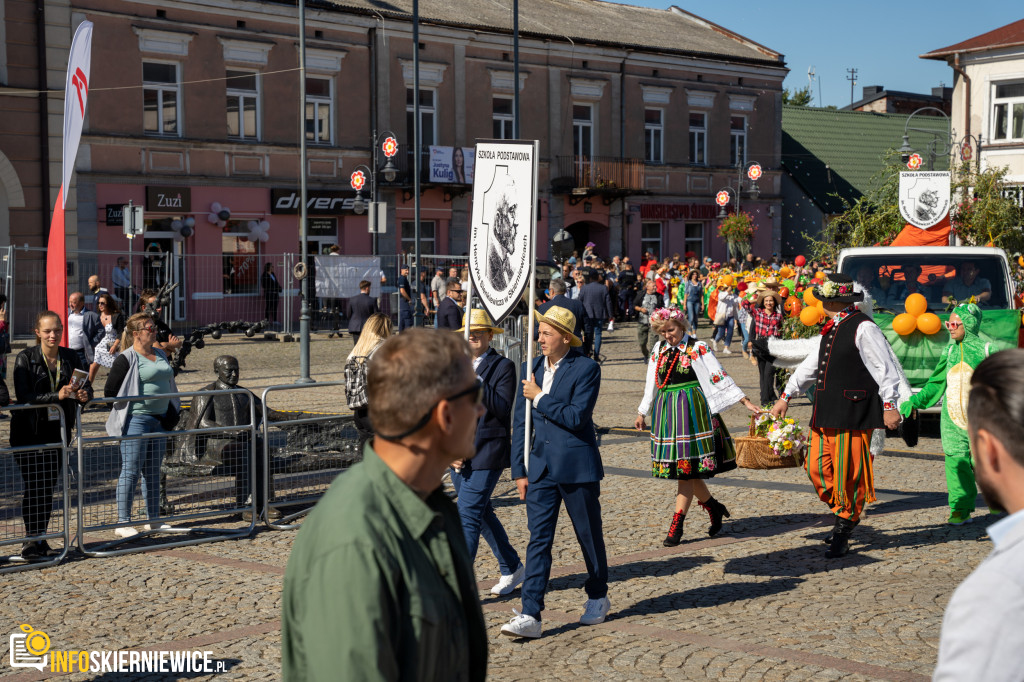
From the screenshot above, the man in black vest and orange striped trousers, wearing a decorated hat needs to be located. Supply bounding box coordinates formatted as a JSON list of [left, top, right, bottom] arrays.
[[772, 273, 900, 558]]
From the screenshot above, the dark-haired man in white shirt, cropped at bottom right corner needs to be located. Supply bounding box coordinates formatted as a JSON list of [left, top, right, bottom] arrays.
[[933, 348, 1024, 682]]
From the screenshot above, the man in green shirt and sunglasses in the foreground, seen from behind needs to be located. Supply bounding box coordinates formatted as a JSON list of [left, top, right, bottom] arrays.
[[282, 329, 487, 680]]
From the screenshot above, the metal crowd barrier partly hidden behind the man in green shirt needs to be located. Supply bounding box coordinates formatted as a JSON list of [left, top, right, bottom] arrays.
[[261, 381, 362, 530]]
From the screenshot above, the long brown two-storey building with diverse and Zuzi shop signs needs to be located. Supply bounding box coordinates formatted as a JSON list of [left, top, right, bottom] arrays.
[[6, 0, 786, 322]]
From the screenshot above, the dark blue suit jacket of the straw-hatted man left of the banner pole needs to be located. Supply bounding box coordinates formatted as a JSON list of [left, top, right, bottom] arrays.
[[468, 351, 516, 470]]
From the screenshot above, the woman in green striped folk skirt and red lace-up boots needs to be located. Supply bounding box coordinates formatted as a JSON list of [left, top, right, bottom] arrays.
[[635, 308, 760, 547]]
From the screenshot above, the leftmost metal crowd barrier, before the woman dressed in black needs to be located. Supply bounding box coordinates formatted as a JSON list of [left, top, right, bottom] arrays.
[[0, 404, 71, 573]]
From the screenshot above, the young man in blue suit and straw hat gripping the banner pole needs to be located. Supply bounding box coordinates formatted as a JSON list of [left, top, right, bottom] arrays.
[[502, 306, 611, 638]]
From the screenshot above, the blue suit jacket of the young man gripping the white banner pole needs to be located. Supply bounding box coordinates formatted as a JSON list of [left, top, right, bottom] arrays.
[[512, 348, 604, 483]]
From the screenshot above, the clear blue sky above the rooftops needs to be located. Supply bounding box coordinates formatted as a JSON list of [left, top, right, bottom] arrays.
[[613, 0, 1022, 106]]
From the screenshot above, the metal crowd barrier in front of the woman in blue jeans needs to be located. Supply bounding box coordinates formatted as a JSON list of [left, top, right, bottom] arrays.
[[76, 388, 262, 557]]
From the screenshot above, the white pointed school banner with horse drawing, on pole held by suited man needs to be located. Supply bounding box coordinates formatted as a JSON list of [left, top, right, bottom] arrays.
[[469, 140, 538, 323]]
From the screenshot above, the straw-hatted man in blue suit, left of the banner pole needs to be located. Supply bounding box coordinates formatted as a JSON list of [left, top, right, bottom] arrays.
[[452, 308, 524, 595]]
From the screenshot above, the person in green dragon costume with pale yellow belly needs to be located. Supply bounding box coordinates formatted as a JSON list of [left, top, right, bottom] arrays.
[[900, 303, 989, 525]]
